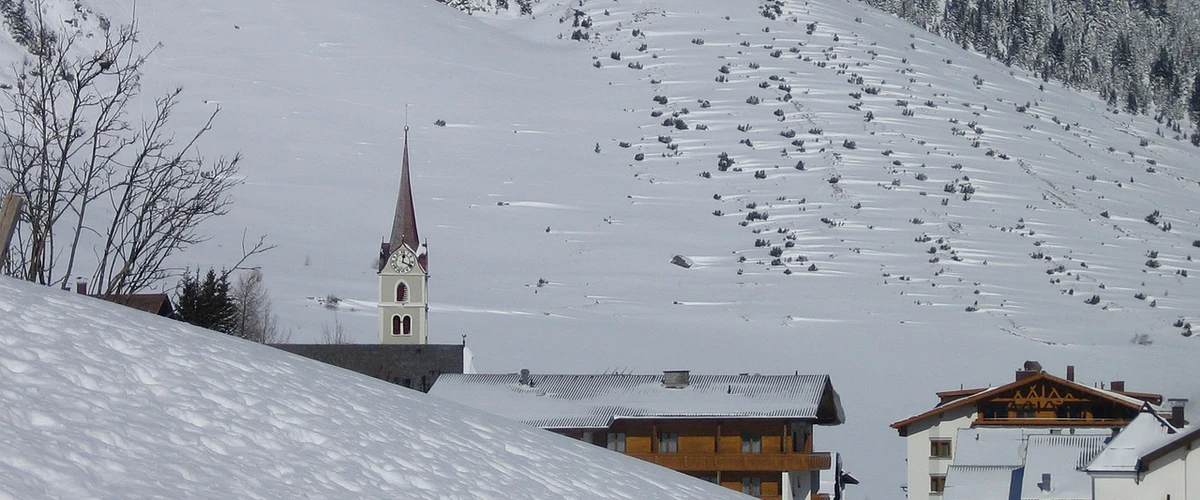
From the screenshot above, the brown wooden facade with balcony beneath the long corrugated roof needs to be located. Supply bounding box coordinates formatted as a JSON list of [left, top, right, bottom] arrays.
[[553, 418, 833, 500]]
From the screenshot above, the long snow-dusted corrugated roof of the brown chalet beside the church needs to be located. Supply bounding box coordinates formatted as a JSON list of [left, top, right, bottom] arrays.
[[430, 373, 845, 428]]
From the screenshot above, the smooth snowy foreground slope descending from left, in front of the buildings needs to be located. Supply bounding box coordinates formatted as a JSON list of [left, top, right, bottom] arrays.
[[0, 278, 745, 500]]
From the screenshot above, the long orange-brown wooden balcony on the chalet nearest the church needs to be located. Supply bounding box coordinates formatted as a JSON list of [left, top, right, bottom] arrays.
[[626, 453, 832, 472]]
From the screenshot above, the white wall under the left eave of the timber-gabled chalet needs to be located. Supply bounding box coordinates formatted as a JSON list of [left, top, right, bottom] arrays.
[[907, 405, 976, 500]]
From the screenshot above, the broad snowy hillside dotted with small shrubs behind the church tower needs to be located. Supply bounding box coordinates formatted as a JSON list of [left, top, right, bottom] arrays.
[[7, 0, 1200, 498]]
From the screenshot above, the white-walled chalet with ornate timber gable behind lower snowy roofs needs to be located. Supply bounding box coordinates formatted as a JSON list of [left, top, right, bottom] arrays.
[[892, 361, 1163, 499]]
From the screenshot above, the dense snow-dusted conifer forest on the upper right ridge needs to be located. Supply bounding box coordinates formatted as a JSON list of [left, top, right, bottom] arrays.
[[865, 0, 1200, 139]]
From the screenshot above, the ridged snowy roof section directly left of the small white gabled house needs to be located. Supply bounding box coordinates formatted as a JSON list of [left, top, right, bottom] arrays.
[[1021, 434, 1108, 500]]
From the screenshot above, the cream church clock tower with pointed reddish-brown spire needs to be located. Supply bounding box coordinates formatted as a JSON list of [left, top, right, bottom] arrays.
[[379, 126, 430, 344]]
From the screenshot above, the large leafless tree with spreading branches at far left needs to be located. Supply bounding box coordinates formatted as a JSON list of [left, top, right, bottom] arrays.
[[0, 2, 270, 295]]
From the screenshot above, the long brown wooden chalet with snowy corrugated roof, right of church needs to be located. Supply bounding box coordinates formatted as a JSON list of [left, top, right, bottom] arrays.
[[430, 371, 856, 499]]
